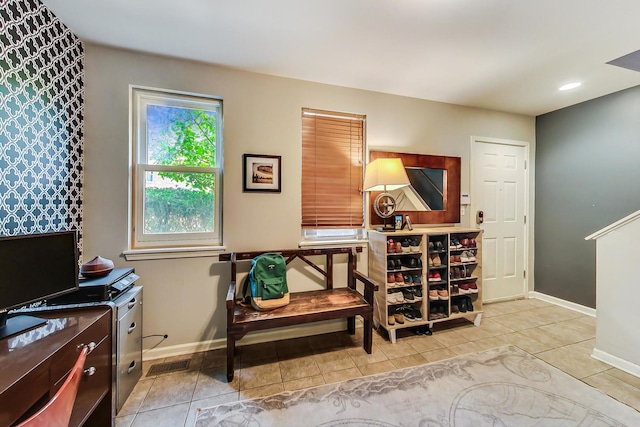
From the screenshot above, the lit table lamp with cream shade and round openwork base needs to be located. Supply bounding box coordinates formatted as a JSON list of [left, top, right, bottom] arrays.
[[362, 158, 410, 231]]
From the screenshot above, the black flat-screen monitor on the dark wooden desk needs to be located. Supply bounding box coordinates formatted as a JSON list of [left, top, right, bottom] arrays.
[[0, 231, 79, 339]]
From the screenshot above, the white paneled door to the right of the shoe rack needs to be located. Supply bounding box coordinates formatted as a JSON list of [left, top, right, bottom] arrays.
[[471, 138, 528, 302]]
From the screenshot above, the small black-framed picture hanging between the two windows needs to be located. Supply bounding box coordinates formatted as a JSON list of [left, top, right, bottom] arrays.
[[242, 154, 282, 193]]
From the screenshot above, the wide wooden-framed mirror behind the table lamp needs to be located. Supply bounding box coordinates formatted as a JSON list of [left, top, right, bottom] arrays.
[[369, 151, 461, 226]]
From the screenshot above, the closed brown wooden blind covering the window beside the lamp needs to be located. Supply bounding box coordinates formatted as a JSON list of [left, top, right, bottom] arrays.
[[302, 108, 365, 228]]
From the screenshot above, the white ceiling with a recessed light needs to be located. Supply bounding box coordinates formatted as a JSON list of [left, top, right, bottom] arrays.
[[42, 0, 640, 116]]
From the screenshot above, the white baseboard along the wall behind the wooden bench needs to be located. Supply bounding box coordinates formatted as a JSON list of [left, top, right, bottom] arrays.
[[142, 319, 348, 361]]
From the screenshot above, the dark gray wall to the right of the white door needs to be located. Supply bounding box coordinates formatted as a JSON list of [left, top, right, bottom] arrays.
[[535, 86, 640, 310]]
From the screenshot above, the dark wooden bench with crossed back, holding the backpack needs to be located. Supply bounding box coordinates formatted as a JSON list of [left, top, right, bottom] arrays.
[[220, 247, 378, 381]]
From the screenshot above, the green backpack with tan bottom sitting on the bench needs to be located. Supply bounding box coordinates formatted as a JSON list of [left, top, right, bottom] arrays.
[[242, 253, 289, 311]]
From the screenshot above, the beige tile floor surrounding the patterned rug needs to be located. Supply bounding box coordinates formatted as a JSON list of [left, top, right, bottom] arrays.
[[116, 299, 640, 427]]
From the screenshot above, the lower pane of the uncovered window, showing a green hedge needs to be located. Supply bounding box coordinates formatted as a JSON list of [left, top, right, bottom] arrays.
[[143, 172, 215, 234]]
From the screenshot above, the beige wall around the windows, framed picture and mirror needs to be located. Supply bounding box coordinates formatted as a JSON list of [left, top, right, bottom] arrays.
[[84, 44, 535, 358]]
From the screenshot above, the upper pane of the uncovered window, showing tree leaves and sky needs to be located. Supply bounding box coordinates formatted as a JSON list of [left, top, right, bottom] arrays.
[[146, 104, 217, 167]]
